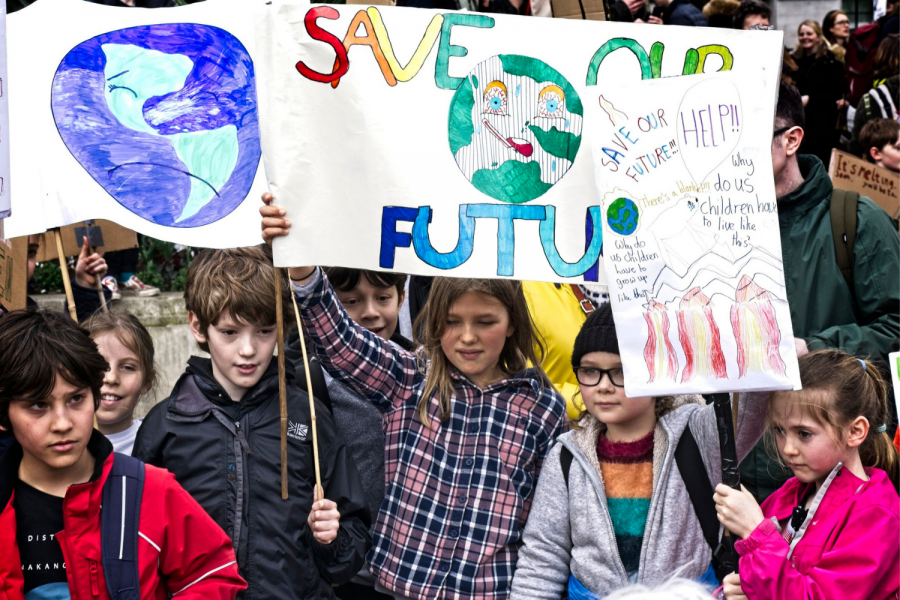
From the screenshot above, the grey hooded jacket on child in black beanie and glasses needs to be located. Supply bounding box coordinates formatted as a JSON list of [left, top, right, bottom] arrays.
[[512, 393, 768, 600]]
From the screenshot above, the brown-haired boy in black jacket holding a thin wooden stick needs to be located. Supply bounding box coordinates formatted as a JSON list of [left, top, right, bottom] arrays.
[[133, 248, 370, 599]]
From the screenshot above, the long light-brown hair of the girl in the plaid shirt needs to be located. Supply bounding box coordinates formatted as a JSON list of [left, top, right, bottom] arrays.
[[413, 277, 546, 427]]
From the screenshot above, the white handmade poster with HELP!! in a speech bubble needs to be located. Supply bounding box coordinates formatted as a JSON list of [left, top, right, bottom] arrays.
[[592, 69, 800, 396]]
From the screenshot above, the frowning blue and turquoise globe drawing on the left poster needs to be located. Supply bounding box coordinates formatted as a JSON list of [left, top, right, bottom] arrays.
[[51, 23, 260, 228]]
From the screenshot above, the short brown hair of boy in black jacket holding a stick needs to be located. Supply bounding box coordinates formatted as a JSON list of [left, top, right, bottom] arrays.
[[184, 246, 291, 352]]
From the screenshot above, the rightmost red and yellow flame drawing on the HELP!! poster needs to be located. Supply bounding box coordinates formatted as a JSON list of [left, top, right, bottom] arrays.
[[731, 275, 785, 377]]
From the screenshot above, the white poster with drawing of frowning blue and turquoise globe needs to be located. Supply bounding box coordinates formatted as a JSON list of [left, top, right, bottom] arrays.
[[7, 0, 265, 247]]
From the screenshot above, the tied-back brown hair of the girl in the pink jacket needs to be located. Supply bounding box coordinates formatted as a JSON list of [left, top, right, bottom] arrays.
[[767, 350, 900, 488]]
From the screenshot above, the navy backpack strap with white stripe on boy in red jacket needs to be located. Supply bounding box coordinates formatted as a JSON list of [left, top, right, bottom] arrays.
[[100, 452, 144, 600]]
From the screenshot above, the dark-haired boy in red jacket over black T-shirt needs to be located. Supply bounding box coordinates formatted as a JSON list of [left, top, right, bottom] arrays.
[[0, 311, 246, 600]]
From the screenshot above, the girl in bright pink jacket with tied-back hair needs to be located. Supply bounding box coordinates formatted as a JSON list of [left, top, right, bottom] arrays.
[[714, 350, 900, 600]]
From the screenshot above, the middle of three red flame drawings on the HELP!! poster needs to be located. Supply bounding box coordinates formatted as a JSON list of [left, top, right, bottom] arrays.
[[678, 287, 728, 383]]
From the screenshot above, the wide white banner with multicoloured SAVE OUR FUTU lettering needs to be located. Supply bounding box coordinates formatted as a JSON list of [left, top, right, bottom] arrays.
[[256, 0, 782, 282]]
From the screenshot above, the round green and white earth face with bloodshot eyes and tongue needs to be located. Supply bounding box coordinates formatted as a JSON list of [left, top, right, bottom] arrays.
[[448, 54, 584, 204]]
